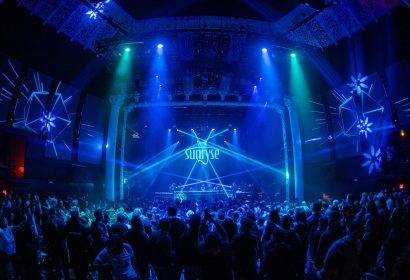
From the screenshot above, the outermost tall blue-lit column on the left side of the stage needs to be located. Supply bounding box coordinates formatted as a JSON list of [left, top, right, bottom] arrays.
[[105, 95, 125, 201]]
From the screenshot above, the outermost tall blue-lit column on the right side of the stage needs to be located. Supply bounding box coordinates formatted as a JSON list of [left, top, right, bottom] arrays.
[[284, 98, 304, 201]]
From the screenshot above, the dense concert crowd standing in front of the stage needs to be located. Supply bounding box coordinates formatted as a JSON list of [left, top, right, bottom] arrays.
[[0, 186, 410, 280]]
